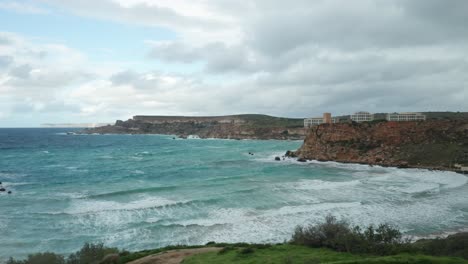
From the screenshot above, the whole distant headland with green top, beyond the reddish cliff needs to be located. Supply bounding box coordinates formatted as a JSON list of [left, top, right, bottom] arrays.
[[83, 115, 306, 140]]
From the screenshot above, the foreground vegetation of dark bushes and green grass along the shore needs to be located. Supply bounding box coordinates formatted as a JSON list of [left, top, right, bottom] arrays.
[[7, 216, 468, 264]]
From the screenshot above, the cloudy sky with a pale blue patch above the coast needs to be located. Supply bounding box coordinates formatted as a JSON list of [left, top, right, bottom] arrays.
[[0, 0, 468, 127]]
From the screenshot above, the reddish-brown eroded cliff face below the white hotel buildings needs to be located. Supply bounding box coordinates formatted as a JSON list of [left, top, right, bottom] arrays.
[[295, 121, 468, 169]]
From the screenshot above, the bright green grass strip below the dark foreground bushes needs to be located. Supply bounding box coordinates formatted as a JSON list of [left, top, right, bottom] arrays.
[[183, 244, 468, 264]]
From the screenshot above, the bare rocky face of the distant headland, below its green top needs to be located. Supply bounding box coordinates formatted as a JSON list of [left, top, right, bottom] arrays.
[[84, 118, 306, 140]]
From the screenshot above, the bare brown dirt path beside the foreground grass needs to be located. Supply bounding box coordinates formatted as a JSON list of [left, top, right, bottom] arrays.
[[128, 247, 222, 264]]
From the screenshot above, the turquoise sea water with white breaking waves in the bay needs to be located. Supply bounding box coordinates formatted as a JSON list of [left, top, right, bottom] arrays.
[[0, 129, 468, 261]]
